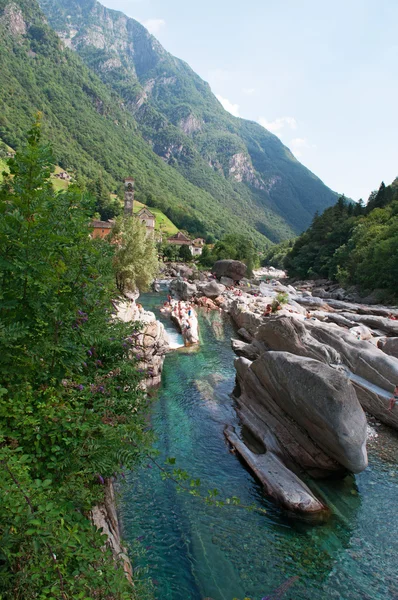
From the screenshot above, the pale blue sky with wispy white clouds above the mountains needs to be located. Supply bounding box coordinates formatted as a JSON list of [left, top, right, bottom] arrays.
[[102, 0, 398, 200]]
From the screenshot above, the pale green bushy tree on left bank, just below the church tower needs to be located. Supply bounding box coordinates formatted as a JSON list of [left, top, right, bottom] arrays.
[[112, 217, 159, 293]]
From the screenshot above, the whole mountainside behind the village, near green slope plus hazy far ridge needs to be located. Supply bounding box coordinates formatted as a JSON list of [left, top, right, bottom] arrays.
[[0, 0, 335, 245]]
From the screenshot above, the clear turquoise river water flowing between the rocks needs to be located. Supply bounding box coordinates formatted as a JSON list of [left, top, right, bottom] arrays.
[[119, 294, 398, 600]]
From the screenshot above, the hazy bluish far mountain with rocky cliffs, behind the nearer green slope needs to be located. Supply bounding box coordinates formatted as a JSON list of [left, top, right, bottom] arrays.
[[40, 0, 336, 240]]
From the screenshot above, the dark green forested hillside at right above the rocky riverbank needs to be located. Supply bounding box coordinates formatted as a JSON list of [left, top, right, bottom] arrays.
[[276, 180, 398, 301]]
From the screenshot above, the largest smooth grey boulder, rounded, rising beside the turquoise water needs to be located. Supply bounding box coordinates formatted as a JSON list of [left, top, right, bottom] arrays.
[[235, 352, 367, 475]]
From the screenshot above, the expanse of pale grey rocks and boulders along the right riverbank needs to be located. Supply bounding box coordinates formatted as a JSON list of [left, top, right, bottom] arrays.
[[166, 261, 398, 512]]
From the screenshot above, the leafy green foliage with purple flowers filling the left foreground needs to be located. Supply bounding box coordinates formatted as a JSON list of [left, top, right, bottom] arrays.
[[0, 123, 154, 600]]
